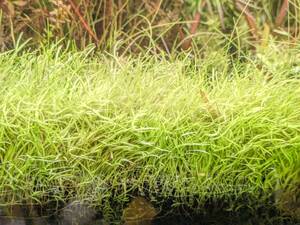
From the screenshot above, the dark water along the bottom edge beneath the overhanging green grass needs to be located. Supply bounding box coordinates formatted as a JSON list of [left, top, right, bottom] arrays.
[[0, 203, 300, 225]]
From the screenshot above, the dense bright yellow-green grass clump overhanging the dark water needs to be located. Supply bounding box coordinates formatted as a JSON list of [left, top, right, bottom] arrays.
[[0, 44, 300, 207]]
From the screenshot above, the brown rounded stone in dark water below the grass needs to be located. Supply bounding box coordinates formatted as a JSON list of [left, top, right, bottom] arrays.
[[122, 197, 158, 225]]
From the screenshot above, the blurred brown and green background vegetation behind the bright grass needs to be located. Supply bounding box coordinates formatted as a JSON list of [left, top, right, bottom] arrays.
[[0, 0, 300, 52]]
